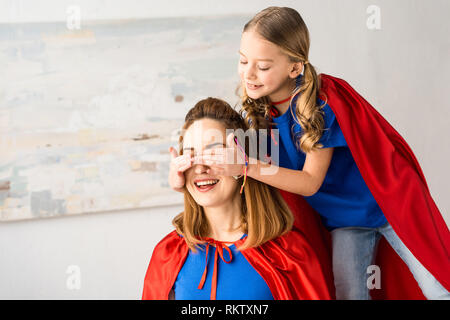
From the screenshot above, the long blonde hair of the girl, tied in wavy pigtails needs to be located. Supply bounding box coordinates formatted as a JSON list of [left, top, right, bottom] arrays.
[[241, 7, 324, 153]]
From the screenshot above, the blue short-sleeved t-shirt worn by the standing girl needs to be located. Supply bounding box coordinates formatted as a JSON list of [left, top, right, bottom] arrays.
[[273, 99, 387, 230]]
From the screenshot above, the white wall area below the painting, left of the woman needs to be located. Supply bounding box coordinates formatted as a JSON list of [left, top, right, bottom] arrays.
[[0, 207, 182, 299]]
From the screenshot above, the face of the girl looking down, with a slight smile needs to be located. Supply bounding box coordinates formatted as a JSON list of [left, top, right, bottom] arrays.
[[239, 30, 301, 101]]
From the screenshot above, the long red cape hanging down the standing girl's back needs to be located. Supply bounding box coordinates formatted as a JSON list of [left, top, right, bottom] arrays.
[[320, 74, 450, 299]]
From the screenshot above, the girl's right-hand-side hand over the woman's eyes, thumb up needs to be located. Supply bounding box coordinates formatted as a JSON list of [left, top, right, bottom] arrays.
[[194, 133, 245, 176]]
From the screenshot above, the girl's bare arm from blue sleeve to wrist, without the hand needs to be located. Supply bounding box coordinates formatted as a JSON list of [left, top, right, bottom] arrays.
[[247, 148, 334, 196]]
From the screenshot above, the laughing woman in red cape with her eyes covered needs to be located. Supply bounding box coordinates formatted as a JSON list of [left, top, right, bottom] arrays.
[[142, 98, 334, 300]]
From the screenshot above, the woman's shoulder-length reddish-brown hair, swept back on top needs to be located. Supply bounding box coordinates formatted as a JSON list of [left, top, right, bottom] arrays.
[[172, 98, 294, 251]]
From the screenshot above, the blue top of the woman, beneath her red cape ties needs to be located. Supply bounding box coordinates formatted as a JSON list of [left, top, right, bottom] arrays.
[[173, 235, 273, 300]]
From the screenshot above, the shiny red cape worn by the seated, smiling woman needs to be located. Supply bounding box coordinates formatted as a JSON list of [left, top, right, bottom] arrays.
[[142, 220, 334, 300]]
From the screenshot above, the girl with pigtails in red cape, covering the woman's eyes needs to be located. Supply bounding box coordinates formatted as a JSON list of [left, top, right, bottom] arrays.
[[169, 7, 450, 299]]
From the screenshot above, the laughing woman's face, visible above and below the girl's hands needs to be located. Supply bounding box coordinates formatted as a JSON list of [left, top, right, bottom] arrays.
[[183, 119, 239, 207]]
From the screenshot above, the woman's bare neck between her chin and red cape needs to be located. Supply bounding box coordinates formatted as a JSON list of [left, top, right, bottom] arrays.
[[203, 193, 244, 241]]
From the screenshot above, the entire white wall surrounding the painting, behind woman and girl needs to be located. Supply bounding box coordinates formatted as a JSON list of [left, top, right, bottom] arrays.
[[0, 0, 450, 299]]
